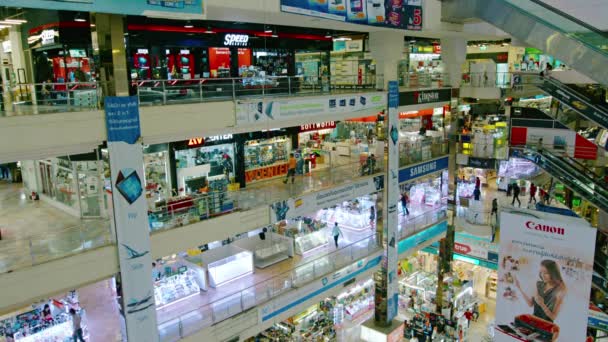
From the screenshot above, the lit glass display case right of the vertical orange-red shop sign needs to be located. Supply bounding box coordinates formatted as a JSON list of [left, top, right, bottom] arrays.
[[245, 137, 291, 171]]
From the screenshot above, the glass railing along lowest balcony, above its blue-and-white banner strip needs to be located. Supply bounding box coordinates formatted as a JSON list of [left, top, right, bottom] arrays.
[[158, 231, 382, 342]]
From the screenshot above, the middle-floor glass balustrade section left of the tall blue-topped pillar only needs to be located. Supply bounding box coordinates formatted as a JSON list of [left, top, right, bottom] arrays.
[[0, 220, 115, 273]]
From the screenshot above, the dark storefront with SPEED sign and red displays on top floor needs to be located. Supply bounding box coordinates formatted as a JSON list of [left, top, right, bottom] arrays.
[[127, 17, 332, 83]]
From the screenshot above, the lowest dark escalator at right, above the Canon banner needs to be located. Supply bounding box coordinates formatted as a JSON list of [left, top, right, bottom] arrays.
[[512, 148, 608, 212]]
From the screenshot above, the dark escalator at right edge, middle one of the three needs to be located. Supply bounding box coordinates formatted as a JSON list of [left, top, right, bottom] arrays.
[[537, 77, 608, 128]]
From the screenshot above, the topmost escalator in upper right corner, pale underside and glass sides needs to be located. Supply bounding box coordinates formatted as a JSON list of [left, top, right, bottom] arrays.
[[442, 0, 608, 85]]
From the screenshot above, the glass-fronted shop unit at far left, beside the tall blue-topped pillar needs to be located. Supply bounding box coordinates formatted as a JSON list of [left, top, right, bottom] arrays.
[[29, 153, 106, 218]]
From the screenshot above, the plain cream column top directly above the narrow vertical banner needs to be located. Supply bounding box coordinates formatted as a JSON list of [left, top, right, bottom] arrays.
[[369, 31, 404, 89]]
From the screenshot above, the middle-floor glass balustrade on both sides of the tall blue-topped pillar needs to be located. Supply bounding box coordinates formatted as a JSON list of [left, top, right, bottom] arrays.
[[0, 161, 385, 273]]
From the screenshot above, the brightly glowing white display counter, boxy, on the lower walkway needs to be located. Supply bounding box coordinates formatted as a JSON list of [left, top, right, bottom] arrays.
[[201, 244, 254, 288]]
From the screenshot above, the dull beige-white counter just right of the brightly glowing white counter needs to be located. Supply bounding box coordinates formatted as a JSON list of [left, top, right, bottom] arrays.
[[233, 232, 293, 268]]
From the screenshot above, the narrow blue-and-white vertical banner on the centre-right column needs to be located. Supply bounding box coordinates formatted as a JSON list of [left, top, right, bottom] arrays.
[[385, 81, 400, 323]]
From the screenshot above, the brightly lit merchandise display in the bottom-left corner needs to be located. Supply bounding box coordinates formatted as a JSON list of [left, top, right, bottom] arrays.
[[0, 291, 89, 342]]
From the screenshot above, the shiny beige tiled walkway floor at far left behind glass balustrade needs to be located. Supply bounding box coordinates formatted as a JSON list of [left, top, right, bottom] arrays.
[[0, 182, 110, 273]]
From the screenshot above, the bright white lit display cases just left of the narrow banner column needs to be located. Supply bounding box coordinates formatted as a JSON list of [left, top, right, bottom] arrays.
[[316, 195, 377, 232]]
